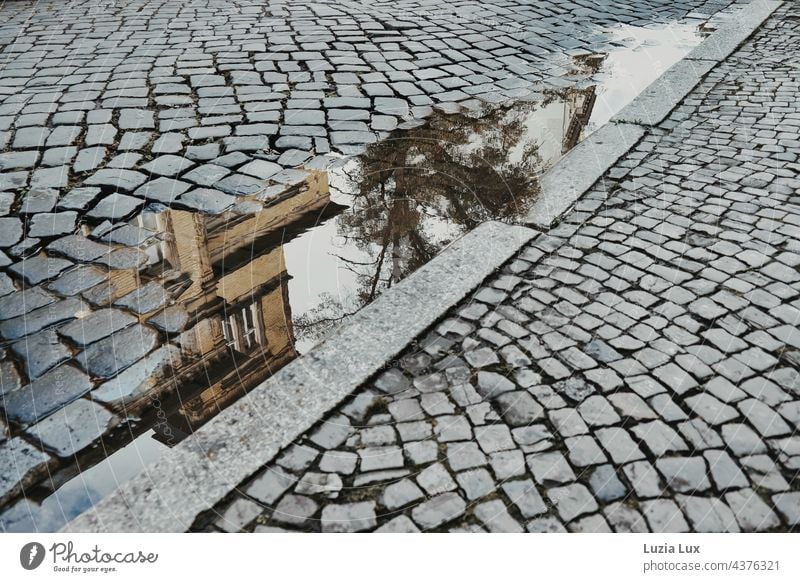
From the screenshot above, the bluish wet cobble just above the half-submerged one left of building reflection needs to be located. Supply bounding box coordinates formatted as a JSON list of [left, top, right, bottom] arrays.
[[77, 324, 158, 378]]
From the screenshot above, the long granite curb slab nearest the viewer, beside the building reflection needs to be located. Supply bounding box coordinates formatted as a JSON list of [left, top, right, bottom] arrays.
[[61, 222, 537, 532]]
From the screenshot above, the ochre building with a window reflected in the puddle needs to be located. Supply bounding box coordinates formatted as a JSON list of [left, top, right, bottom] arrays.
[[122, 172, 330, 446]]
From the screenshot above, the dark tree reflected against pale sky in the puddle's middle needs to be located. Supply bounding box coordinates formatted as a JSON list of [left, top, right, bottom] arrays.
[[295, 89, 593, 340]]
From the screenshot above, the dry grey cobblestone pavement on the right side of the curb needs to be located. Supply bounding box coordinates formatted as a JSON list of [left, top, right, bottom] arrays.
[[196, 4, 800, 532]]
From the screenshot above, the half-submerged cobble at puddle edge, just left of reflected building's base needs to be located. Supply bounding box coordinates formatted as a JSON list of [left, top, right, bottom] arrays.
[[92, 344, 181, 412]]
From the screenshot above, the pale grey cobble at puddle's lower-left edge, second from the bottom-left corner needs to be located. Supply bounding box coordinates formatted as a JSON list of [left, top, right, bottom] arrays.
[[28, 398, 119, 458]]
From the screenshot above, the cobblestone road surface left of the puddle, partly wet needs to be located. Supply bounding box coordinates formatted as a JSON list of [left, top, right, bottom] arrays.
[[0, 0, 744, 524]]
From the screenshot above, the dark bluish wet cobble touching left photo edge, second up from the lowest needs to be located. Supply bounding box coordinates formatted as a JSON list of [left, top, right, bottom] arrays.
[[3, 364, 92, 425]]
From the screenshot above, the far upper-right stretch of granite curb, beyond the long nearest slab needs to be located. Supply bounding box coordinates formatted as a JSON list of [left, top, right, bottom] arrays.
[[525, 0, 783, 230]]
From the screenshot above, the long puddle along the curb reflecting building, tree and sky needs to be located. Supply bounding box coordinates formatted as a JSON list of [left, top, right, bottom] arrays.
[[0, 19, 712, 531]]
